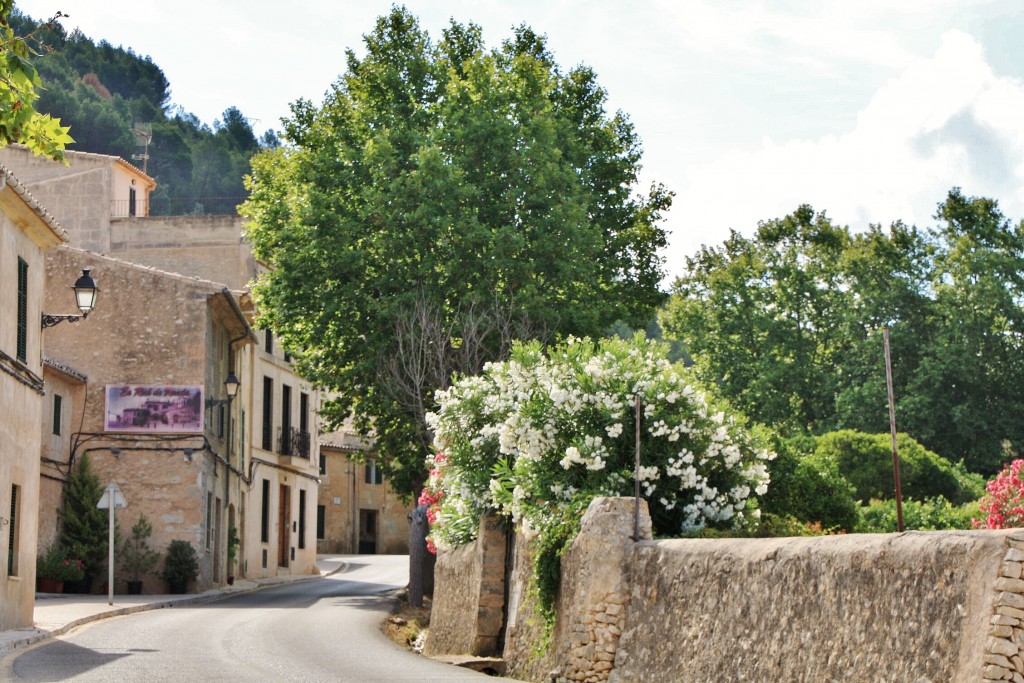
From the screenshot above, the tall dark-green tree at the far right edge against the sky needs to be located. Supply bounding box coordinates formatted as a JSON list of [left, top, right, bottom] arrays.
[[898, 188, 1024, 474]]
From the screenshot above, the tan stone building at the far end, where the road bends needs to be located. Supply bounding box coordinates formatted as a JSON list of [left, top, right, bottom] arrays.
[[316, 430, 413, 555]]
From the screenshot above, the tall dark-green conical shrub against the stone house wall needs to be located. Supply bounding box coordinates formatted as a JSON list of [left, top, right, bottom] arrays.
[[57, 454, 110, 574]]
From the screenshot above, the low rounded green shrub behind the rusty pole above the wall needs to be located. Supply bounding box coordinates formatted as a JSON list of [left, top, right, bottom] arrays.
[[813, 430, 983, 504]]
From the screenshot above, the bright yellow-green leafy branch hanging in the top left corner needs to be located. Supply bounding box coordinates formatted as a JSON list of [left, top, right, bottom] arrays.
[[0, 0, 75, 161]]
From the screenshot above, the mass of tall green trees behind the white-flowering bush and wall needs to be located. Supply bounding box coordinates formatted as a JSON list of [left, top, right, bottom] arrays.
[[663, 189, 1024, 473]]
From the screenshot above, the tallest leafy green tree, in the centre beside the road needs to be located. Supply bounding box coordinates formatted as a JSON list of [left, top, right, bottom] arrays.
[[243, 7, 671, 493]]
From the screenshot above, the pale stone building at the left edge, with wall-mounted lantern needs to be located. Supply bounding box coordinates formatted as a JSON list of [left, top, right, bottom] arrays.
[[0, 166, 69, 631]]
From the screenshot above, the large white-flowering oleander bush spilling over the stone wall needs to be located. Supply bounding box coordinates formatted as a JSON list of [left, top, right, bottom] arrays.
[[426, 337, 773, 548]]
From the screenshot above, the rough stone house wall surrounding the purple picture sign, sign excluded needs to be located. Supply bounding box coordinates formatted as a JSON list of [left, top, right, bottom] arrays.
[[37, 250, 244, 592]]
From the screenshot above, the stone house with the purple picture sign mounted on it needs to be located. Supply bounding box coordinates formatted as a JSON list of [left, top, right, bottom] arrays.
[[37, 248, 255, 592]]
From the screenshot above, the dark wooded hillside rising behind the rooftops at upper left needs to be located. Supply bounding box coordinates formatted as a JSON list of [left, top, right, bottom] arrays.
[[10, 9, 278, 215]]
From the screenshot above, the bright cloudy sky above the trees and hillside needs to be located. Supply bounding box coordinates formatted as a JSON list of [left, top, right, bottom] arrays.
[[15, 0, 1024, 276]]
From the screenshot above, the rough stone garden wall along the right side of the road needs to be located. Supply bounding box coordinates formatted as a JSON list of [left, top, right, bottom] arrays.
[[428, 499, 1024, 683]]
